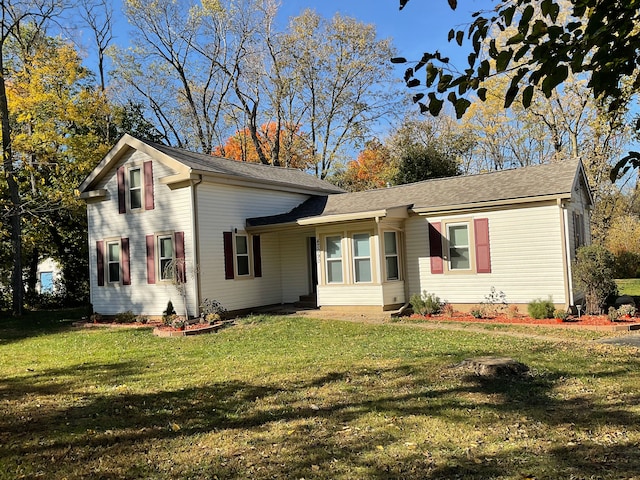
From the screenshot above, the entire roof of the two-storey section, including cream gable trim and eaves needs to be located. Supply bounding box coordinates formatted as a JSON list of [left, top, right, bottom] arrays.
[[79, 134, 344, 195]]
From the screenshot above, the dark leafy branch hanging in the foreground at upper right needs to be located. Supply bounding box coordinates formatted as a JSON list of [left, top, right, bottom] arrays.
[[392, 0, 640, 180]]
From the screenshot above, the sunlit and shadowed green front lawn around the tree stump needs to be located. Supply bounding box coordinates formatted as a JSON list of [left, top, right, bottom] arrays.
[[0, 310, 640, 479]]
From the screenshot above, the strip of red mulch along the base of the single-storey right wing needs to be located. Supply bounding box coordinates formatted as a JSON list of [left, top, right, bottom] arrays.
[[410, 313, 640, 326]]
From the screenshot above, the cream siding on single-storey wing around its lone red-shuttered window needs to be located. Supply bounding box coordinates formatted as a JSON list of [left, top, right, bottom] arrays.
[[405, 202, 565, 304]]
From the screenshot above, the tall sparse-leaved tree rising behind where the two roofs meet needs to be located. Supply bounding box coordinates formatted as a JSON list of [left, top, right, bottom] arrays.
[[285, 10, 398, 178]]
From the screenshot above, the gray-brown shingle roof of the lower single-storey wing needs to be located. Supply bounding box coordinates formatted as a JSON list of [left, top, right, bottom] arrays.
[[247, 159, 580, 226]]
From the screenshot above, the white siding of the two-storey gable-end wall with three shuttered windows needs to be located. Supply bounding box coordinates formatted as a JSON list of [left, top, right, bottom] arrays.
[[87, 150, 198, 315]]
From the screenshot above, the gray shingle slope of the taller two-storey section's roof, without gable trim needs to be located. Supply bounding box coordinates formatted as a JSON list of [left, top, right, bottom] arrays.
[[141, 140, 344, 193]]
